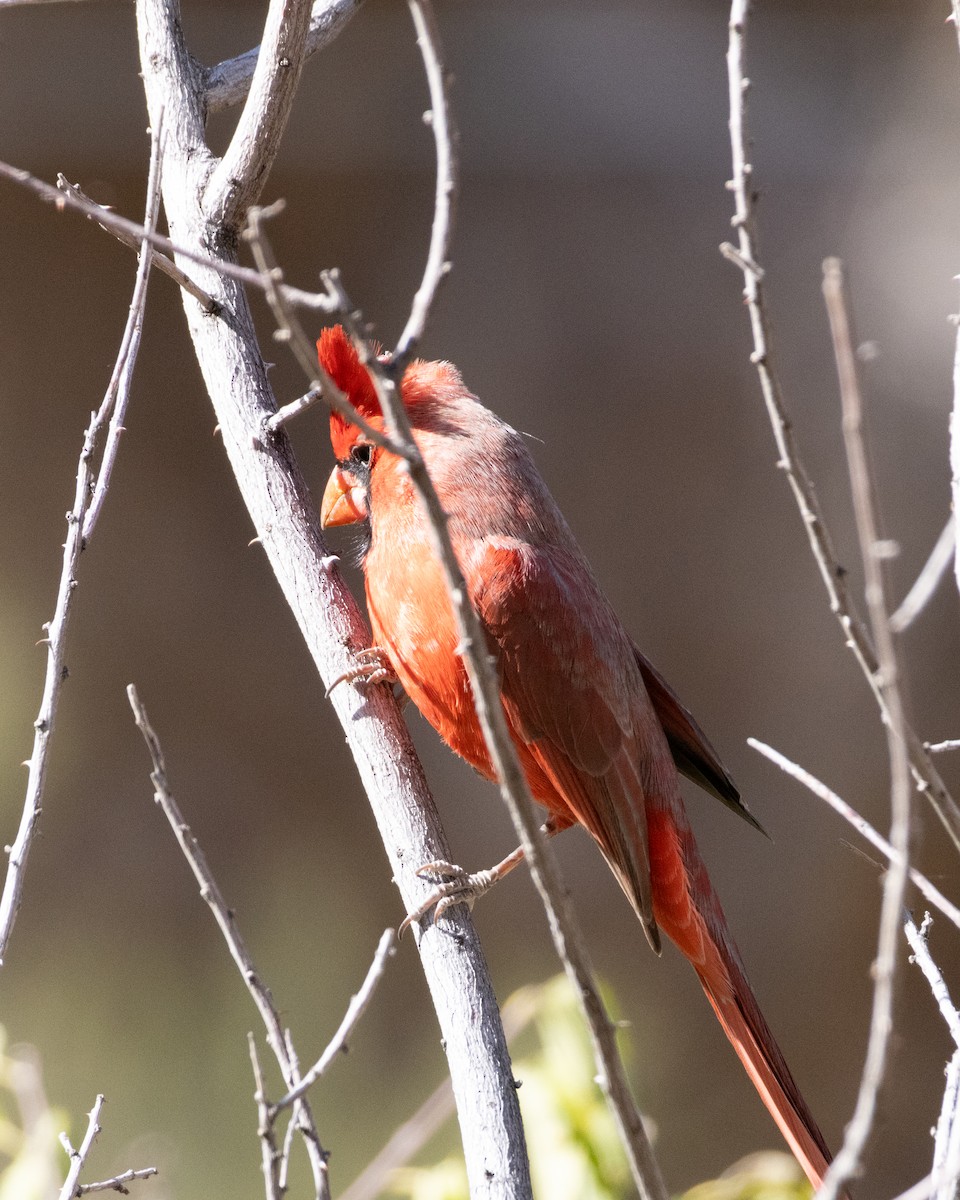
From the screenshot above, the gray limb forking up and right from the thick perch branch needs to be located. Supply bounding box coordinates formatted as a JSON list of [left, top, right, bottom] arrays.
[[203, 0, 311, 229]]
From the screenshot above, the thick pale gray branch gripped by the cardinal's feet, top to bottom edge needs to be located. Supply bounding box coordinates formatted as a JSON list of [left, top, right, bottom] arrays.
[[137, 0, 530, 1198]]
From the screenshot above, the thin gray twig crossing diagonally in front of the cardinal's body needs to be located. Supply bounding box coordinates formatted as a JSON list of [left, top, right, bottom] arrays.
[[324, 272, 667, 1200]]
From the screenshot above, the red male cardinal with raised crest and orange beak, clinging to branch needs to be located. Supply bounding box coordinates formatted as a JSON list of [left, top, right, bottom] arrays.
[[317, 325, 830, 1187]]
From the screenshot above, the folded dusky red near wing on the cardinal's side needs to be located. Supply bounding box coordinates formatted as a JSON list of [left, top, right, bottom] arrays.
[[468, 539, 676, 950]]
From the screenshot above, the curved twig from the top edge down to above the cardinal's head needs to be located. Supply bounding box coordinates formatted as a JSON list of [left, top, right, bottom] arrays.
[[394, 0, 457, 364]]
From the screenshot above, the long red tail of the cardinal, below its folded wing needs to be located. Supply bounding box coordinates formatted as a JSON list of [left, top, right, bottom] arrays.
[[648, 805, 830, 1188]]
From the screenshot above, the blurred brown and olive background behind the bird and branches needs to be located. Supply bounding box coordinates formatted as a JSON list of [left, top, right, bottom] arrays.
[[0, 0, 960, 1200]]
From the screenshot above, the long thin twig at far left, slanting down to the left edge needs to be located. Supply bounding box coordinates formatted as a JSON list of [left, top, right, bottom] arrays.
[[0, 131, 162, 966]]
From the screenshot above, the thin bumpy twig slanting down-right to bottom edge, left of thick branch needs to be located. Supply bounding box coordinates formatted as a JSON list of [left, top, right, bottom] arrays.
[[127, 684, 330, 1200]]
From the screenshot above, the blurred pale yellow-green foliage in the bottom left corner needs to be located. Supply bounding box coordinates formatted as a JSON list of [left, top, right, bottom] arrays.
[[0, 1026, 66, 1200]]
